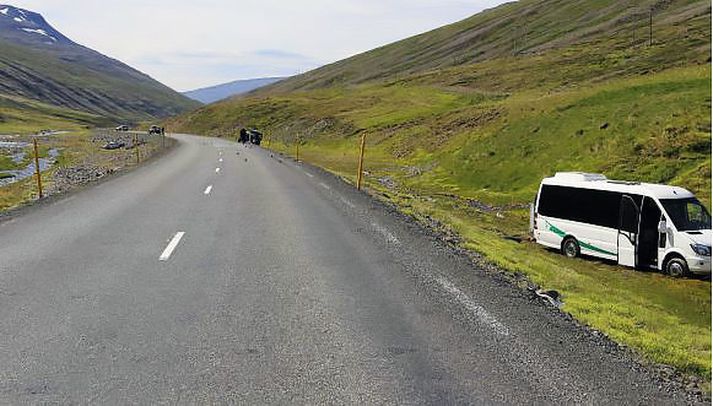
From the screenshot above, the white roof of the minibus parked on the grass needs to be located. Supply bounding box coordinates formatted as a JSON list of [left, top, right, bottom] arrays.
[[542, 172, 693, 199]]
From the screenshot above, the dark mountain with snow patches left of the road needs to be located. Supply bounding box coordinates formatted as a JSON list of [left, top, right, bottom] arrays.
[[0, 5, 197, 120]]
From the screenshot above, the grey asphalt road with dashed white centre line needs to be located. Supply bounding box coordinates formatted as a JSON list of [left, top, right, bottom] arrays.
[[0, 136, 685, 404]]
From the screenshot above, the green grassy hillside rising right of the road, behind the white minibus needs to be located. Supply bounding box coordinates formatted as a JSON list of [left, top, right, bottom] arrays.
[[169, 0, 711, 380]]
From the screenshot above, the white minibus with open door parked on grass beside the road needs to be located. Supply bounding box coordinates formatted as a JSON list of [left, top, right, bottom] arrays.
[[530, 172, 711, 277]]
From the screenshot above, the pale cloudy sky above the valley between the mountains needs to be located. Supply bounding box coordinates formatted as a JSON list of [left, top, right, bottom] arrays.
[[4, 0, 505, 91]]
